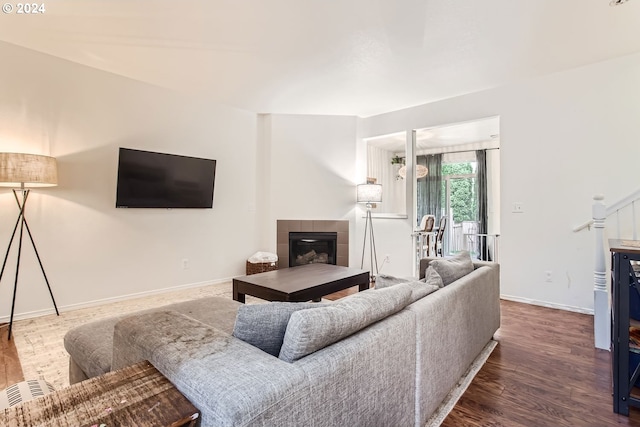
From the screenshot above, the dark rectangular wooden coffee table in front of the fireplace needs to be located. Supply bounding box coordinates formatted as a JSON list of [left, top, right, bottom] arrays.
[[233, 264, 369, 302]]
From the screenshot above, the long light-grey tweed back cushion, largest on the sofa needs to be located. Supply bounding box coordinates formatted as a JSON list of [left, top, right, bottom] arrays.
[[279, 283, 411, 362]]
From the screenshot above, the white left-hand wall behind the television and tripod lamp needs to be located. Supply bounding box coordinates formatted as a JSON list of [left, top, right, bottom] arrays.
[[0, 43, 259, 321]]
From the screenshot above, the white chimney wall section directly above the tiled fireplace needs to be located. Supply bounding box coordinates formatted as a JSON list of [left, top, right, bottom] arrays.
[[258, 114, 359, 267]]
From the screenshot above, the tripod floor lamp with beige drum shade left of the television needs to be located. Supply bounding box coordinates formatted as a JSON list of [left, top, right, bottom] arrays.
[[0, 153, 60, 339]]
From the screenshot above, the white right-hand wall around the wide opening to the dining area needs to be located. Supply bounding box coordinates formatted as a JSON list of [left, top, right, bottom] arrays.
[[360, 54, 640, 310]]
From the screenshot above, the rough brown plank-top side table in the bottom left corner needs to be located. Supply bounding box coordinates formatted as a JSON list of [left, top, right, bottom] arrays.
[[0, 361, 200, 427]]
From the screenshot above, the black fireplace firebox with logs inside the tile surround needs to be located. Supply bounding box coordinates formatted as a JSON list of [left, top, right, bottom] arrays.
[[289, 232, 338, 267]]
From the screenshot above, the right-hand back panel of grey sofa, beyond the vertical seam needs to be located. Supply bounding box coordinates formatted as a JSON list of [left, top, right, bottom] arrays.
[[407, 263, 500, 425]]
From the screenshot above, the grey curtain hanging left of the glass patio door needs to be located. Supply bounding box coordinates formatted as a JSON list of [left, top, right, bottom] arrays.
[[416, 154, 442, 226]]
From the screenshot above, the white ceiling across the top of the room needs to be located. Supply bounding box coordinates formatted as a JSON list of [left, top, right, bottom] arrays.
[[0, 0, 640, 116]]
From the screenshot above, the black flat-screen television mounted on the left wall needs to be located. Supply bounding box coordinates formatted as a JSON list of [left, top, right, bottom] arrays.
[[116, 148, 216, 208]]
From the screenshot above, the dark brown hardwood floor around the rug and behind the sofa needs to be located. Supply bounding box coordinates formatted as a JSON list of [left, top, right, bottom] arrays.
[[0, 287, 640, 427]]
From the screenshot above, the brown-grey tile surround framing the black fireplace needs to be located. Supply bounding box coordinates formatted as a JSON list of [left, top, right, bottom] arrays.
[[276, 219, 349, 268]]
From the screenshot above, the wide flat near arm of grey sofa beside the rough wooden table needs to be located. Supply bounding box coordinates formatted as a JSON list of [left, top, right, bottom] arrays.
[[113, 311, 309, 427]]
